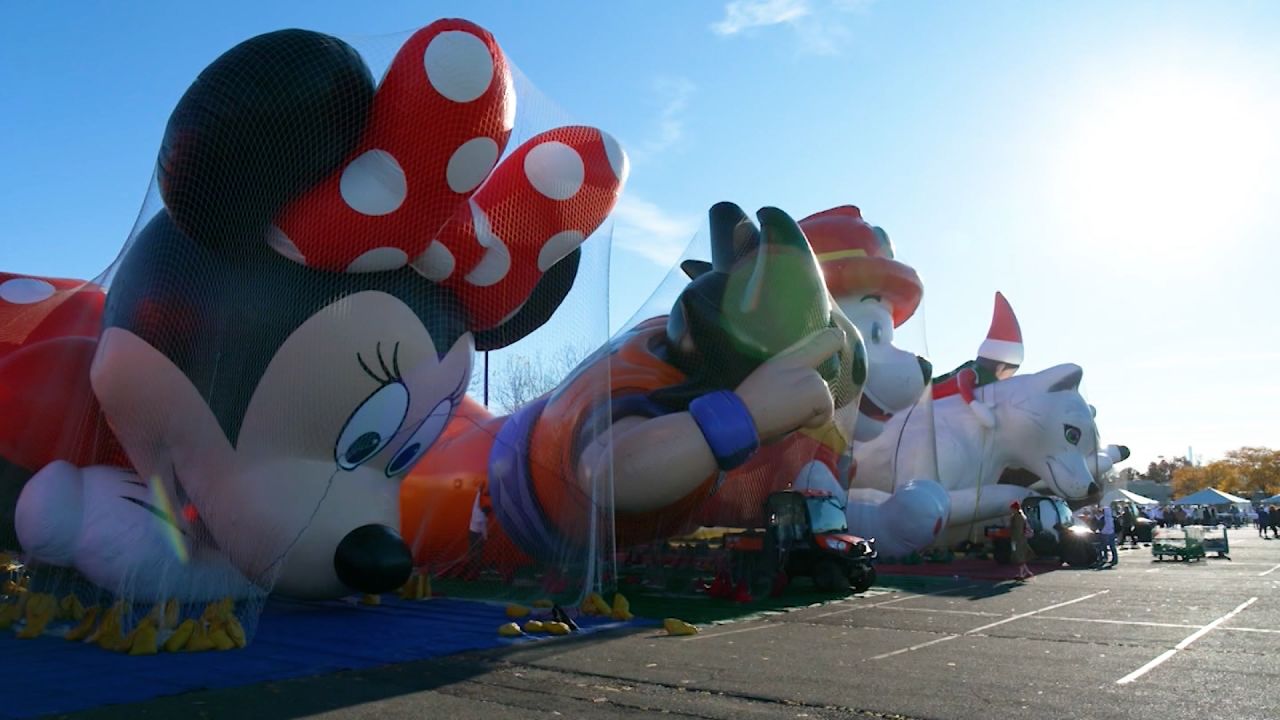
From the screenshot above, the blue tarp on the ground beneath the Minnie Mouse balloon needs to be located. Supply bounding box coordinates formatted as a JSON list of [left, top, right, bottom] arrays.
[[0, 598, 626, 719]]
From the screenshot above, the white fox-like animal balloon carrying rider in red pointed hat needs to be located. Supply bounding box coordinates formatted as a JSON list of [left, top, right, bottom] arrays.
[[847, 292, 1123, 555]]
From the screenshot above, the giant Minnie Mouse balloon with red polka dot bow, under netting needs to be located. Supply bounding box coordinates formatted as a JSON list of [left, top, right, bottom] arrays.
[[0, 20, 624, 609]]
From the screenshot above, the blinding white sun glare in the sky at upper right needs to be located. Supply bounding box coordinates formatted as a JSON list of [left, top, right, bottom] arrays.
[[1060, 69, 1280, 260]]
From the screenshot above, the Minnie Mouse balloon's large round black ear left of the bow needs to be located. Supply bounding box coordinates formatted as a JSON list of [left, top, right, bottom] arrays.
[[157, 29, 374, 246]]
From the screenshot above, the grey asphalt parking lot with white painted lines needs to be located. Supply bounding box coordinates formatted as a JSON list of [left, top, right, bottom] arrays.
[[55, 529, 1280, 720]]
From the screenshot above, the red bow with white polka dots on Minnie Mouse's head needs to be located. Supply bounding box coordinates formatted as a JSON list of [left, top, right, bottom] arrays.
[[270, 19, 627, 329]]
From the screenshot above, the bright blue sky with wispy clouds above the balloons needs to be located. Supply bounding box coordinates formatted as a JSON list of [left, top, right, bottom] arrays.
[[0, 0, 1280, 464]]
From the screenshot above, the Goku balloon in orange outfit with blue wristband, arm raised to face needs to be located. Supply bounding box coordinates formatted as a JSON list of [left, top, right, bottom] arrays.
[[402, 202, 865, 568]]
